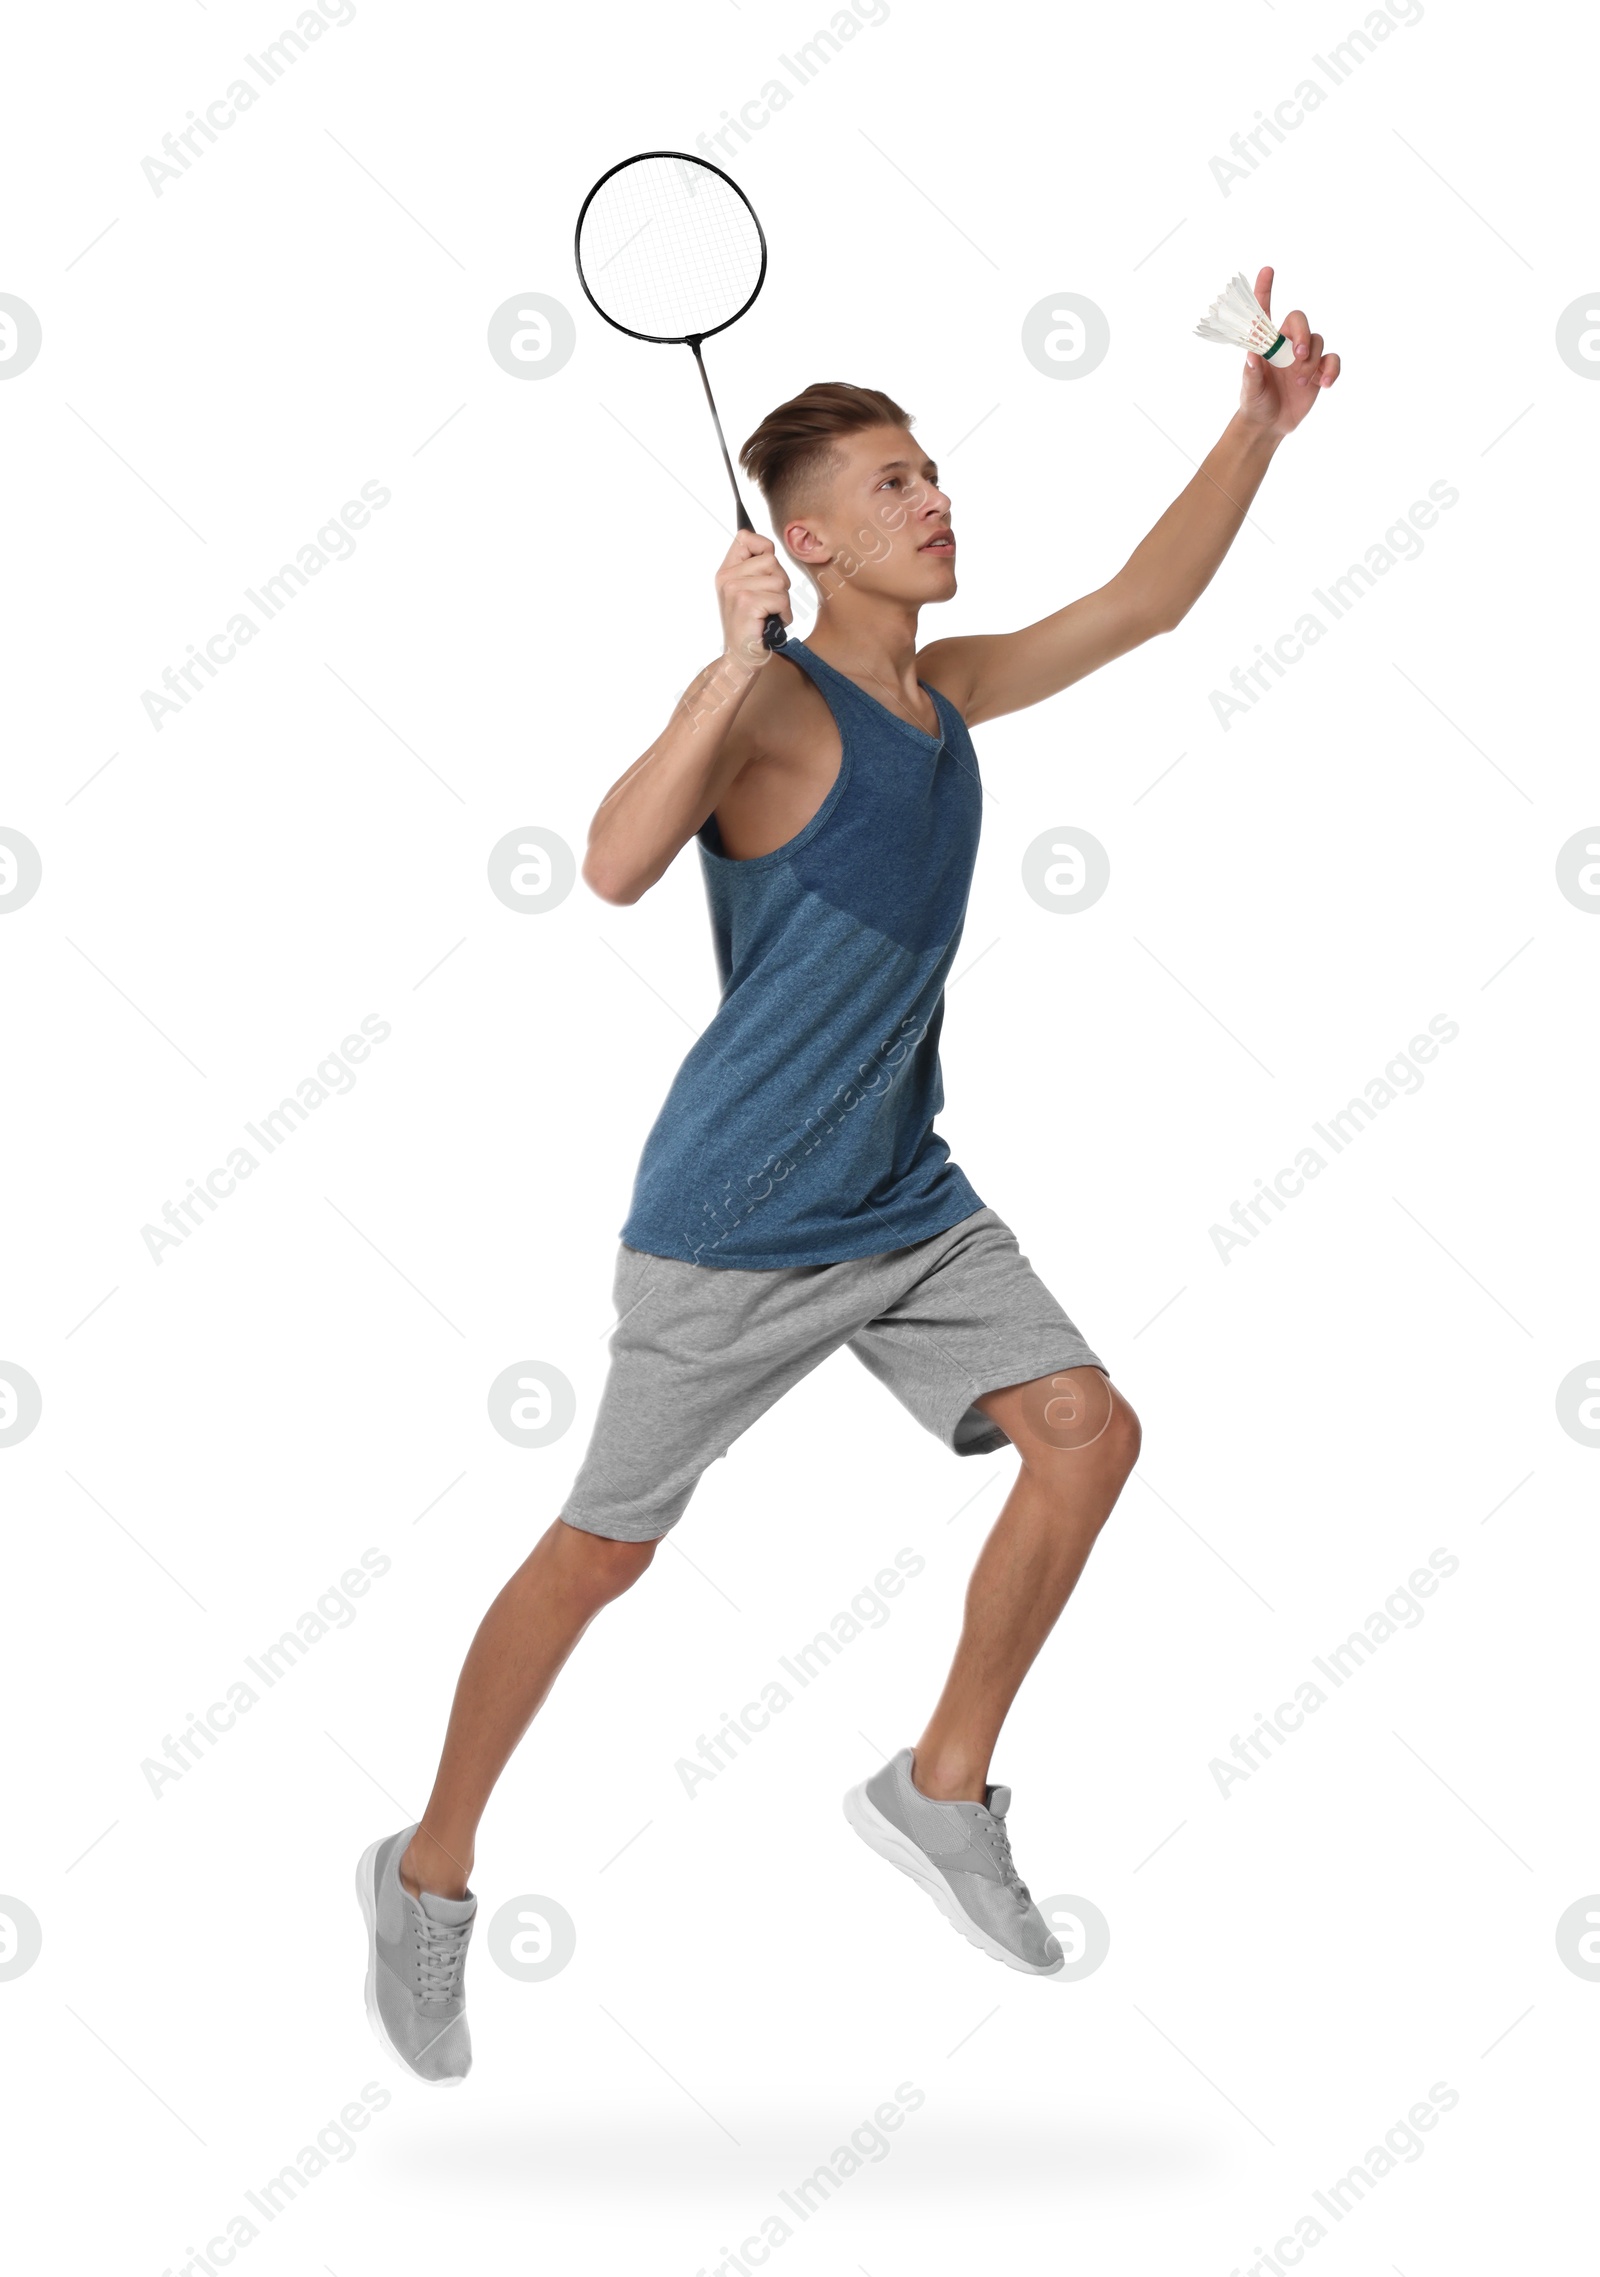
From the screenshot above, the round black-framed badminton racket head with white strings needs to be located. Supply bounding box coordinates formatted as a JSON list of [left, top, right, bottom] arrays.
[[574, 150, 767, 346]]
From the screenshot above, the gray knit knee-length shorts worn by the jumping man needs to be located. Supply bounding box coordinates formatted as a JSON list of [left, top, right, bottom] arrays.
[[560, 1209, 1104, 1542]]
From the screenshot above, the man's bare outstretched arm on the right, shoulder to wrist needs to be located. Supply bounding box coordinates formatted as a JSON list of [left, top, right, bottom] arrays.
[[917, 414, 1279, 726]]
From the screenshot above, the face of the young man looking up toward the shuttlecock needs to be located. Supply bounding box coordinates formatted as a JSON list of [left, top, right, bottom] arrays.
[[783, 426, 956, 608]]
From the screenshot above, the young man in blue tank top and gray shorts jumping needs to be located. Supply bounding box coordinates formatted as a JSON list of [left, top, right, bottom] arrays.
[[357, 269, 1338, 2083]]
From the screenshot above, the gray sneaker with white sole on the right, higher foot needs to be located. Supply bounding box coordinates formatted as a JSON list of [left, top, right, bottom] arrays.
[[844, 1746, 1065, 1976]]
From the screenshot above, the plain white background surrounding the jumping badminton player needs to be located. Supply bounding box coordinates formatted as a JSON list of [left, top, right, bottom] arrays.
[[0, 0, 1600, 2277]]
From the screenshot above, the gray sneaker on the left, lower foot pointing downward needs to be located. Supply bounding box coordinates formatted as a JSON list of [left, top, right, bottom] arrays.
[[355, 1826, 478, 2088]]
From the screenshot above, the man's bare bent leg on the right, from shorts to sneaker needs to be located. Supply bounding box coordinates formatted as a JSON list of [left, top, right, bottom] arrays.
[[910, 1368, 1140, 1803]]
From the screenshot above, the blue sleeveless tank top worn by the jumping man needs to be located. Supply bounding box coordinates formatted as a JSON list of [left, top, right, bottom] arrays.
[[621, 640, 983, 1266]]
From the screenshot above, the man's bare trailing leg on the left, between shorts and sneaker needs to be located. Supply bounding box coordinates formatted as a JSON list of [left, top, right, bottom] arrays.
[[401, 1519, 655, 1897]]
